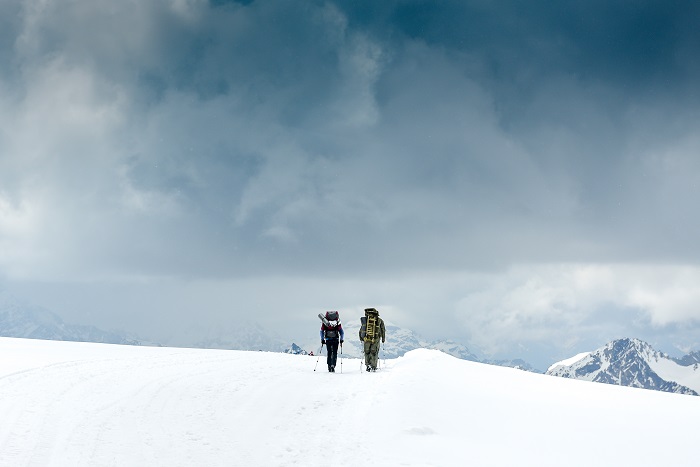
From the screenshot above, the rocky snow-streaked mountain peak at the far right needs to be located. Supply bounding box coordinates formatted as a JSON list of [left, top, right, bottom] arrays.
[[547, 339, 700, 395]]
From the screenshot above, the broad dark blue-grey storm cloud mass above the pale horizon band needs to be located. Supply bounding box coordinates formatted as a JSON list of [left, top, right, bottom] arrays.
[[2, 1, 700, 275]]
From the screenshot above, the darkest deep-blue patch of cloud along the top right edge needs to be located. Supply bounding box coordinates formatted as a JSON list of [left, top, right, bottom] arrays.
[[341, 0, 698, 92]]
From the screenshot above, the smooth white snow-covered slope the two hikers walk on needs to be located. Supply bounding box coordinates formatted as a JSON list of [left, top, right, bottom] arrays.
[[0, 338, 700, 467]]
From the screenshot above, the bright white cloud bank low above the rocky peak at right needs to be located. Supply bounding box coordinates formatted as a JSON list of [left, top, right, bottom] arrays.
[[456, 264, 700, 353]]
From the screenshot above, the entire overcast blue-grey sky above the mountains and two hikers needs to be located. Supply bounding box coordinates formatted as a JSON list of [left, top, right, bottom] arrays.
[[0, 0, 700, 366]]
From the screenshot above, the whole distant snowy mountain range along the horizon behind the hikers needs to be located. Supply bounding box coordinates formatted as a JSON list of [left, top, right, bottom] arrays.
[[5, 295, 700, 395]]
